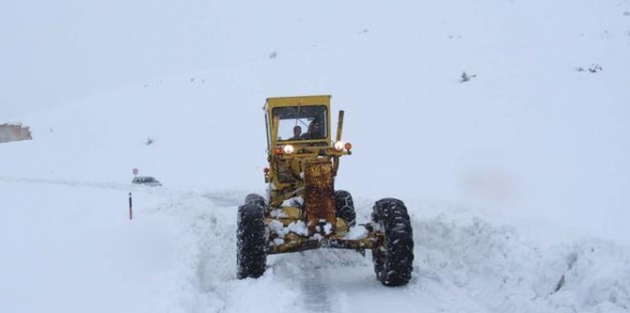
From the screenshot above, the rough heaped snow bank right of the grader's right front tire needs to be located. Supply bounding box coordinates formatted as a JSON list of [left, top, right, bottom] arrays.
[[414, 216, 630, 312]]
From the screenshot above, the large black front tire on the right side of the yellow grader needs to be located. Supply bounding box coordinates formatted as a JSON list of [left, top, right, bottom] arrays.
[[372, 198, 413, 286]]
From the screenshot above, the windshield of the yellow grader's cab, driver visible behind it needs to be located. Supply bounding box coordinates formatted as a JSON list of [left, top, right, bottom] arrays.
[[273, 105, 328, 140]]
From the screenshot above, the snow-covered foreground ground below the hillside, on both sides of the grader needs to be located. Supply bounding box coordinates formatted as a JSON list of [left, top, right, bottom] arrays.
[[0, 179, 630, 313]]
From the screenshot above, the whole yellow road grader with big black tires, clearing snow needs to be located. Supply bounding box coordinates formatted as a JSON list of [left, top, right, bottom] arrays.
[[237, 95, 413, 286]]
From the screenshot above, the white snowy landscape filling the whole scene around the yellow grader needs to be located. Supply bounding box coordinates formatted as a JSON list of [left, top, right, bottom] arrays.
[[0, 0, 630, 313]]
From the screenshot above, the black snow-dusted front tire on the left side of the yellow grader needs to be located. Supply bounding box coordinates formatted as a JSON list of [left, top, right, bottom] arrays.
[[236, 195, 267, 279]]
